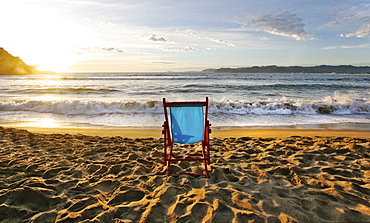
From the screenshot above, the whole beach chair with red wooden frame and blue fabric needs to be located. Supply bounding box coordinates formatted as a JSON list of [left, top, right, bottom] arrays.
[[162, 97, 211, 178]]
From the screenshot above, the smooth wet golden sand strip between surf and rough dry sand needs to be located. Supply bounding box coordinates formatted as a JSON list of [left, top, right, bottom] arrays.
[[0, 125, 370, 138]]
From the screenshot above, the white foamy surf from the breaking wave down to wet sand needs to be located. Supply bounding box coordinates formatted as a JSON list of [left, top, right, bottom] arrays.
[[0, 92, 370, 127]]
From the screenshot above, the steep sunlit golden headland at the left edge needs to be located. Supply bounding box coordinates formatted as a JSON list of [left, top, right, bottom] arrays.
[[0, 47, 52, 75]]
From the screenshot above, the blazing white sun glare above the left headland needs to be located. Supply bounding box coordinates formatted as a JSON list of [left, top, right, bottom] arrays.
[[0, 1, 89, 72]]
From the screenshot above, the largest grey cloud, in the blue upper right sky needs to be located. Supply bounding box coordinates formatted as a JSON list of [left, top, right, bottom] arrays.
[[239, 11, 312, 40]]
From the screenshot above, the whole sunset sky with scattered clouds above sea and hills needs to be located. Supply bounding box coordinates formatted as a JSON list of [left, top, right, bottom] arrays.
[[0, 0, 370, 72]]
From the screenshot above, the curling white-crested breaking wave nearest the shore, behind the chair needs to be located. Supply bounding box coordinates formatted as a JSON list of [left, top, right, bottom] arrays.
[[0, 93, 370, 116]]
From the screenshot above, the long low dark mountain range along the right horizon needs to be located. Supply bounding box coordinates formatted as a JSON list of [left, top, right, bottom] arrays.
[[202, 65, 370, 74]]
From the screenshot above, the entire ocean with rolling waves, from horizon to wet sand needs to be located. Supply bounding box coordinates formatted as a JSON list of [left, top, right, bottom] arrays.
[[0, 72, 370, 130]]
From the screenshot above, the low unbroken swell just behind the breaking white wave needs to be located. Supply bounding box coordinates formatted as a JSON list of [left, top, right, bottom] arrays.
[[2, 84, 368, 96]]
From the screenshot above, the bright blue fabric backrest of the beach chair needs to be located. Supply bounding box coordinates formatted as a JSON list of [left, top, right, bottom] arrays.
[[170, 104, 204, 144]]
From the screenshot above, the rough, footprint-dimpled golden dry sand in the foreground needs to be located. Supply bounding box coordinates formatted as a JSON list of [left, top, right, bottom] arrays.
[[0, 127, 370, 223]]
